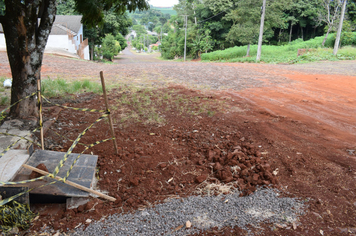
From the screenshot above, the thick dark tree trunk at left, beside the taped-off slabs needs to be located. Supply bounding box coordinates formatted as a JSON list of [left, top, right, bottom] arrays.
[[0, 0, 56, 119]]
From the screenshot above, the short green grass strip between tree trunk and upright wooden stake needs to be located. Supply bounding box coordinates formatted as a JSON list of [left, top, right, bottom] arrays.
[[41, 79, 102, 98]]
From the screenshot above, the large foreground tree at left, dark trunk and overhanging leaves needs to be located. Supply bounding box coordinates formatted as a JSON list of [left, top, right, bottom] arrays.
[[0, 0, 149, 118]]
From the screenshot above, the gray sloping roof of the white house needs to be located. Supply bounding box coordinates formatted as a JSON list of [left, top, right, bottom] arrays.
[[0, 15, 82, 35]]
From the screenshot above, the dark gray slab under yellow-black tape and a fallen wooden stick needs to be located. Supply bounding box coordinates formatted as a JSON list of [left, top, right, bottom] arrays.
[[14, 150, 98, 197]]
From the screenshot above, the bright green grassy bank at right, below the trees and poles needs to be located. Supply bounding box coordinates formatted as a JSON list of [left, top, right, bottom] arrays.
[[202, 34, 356, 63]]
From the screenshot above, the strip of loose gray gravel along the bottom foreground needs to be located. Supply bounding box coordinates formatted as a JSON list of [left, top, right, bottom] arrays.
[[73, 189, 304, 235]]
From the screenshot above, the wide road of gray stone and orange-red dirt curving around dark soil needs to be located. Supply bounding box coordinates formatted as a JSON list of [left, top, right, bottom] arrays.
[[0, 49, 356, 235]]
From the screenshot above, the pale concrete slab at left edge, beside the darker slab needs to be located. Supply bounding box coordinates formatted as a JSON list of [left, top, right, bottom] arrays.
[[0, 150, 29, 182]]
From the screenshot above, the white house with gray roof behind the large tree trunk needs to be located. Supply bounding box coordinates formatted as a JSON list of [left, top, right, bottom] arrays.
[[0, 15, 90, 60]]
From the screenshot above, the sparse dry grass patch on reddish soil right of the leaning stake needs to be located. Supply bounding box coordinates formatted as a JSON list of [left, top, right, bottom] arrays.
[[112, 85, 222, 126]]
